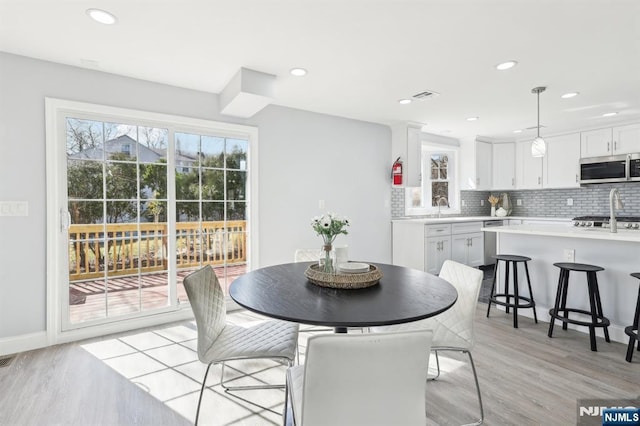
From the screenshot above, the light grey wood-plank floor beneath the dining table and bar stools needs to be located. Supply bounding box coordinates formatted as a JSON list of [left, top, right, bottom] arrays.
[[0, 303, 640, 425]]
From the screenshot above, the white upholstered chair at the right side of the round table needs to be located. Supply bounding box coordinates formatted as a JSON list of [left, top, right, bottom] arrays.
[[371, 260, 484, 425]]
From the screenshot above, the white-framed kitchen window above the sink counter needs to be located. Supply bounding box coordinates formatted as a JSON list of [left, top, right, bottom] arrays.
[[405, 143, 460, 215]]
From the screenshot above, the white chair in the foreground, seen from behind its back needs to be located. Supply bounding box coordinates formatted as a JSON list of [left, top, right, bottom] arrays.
[[285, 330, 432, 426]]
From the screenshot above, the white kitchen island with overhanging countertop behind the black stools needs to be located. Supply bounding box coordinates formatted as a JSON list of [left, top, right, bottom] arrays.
[[482, 223, 640, 343]]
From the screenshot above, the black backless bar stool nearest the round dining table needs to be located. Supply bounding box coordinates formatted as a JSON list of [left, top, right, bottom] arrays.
[[487, 254, 538, 328]]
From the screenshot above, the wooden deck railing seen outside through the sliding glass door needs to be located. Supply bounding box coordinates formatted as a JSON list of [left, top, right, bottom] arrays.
[[69, 220, 247, 281]]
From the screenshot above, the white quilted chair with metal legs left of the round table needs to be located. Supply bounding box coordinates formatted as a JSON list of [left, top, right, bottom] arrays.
[[184, 265, 298, 425]]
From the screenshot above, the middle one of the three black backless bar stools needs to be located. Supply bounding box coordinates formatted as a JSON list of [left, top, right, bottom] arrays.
[[548, 262, 611, 351]]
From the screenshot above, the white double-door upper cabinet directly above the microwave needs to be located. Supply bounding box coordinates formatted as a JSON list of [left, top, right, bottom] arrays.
[[580, 124, 640, 158]]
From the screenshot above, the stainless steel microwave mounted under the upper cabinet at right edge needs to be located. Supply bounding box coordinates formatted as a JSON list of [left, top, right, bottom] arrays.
[[580, 153, 640, 185]]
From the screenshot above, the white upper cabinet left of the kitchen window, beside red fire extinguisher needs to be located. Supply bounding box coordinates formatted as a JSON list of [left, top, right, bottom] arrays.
[[391, 123, 422, 187]]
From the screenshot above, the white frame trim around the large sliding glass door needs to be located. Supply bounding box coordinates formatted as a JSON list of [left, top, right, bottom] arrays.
[[43, 97, 259, 346]]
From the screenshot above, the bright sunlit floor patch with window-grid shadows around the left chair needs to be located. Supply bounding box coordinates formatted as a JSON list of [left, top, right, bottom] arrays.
[[80, 311, 324, 426]]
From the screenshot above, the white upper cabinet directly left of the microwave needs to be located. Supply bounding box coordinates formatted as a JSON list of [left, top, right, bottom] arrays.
[[543, 133, 580, 188]]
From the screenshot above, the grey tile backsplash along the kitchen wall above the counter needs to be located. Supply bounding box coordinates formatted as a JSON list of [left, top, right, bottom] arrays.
[[391, 182, 640, 218]]
